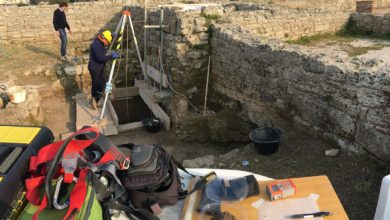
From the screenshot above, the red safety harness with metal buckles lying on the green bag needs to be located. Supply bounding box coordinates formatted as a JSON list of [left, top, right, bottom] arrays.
[[26, 127, 130, 219]]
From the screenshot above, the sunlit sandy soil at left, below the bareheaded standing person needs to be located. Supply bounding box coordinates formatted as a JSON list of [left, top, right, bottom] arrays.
[[0, 43, 79, 138]]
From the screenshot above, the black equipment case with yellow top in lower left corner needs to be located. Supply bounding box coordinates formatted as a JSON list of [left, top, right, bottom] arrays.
[[0, 125, 54, 219]]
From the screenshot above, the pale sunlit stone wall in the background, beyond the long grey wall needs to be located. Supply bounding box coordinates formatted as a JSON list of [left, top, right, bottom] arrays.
[[222, 5, 349, 39]]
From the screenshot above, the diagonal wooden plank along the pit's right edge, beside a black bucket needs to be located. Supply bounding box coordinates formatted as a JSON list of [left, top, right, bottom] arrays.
[[138, 83, 171, 130]]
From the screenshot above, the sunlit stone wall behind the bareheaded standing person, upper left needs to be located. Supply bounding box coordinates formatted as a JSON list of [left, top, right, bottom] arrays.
[[0, 2, 123, 43]]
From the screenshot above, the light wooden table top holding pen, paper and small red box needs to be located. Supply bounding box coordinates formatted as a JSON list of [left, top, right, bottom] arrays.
[[181, 176, 349, 220]]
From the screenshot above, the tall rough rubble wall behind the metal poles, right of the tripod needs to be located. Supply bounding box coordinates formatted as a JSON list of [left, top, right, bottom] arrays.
[[132, 7, 209, 92]]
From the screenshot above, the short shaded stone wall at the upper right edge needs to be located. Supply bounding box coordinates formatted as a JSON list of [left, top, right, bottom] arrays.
[[349, 13, 390, 35]]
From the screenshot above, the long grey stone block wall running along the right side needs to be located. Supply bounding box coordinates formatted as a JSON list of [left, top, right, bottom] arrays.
[[212, 25, 390, 160]]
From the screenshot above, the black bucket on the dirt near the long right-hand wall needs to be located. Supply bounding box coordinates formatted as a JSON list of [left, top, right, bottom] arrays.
[[249, 127, 280, 155]]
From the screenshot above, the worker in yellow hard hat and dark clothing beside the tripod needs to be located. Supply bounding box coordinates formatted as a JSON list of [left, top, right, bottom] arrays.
[[88, 30, 119, 109]]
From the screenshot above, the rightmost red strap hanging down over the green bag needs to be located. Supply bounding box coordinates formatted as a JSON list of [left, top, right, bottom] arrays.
[[64, 170, 87, 220]]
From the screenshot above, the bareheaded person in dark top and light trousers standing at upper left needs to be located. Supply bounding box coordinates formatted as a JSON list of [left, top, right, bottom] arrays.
[[53, 2, 72, 61]]
